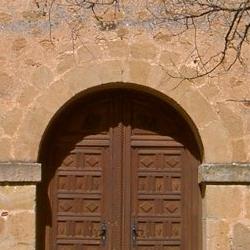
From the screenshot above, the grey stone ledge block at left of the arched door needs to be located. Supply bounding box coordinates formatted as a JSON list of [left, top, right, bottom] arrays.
[[0, 162, 41, 183]]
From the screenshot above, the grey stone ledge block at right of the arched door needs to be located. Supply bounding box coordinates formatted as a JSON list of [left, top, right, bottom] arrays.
[[198, 163, 250, 184]]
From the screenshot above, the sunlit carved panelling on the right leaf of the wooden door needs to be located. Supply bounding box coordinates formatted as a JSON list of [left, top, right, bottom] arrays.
[[132, 147, 183, 250]]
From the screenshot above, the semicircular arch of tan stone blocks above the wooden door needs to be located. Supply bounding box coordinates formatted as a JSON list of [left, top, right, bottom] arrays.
[[12, 59, 232, 162]]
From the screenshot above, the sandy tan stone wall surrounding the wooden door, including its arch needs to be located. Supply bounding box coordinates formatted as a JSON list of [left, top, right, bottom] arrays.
[[0, 0, 250, 250]]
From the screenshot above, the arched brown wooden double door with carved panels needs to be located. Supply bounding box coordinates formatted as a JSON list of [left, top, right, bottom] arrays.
[[38, 90, 201, 250]]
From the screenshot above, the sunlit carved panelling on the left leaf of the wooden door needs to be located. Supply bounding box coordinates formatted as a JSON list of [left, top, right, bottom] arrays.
[[53, 146, 110, 250]]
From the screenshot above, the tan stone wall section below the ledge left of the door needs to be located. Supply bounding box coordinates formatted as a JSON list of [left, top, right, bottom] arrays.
[[0, 184, 36, 250]]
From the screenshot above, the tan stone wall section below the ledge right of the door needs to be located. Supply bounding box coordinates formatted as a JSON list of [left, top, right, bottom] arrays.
[[203, 185, 250, 250]]
